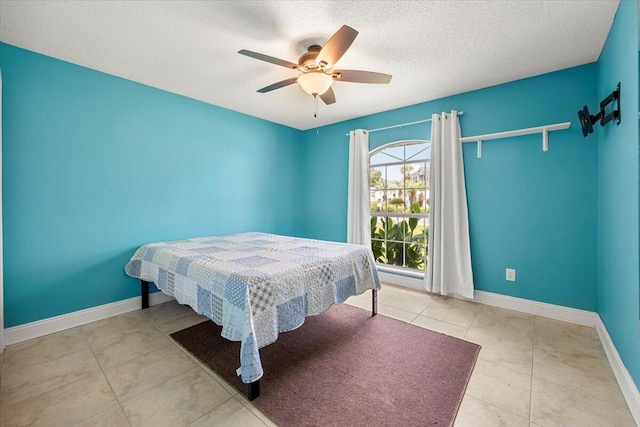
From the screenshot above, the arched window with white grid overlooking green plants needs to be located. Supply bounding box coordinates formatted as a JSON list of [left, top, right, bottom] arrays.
[[369, 140, 431, 271]]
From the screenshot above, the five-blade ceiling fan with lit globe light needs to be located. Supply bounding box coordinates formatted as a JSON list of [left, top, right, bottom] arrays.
[[238, 25, 391, 105]]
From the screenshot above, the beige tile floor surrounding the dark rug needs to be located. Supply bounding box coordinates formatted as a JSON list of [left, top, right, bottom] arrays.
[[0, 285, 635, 427]]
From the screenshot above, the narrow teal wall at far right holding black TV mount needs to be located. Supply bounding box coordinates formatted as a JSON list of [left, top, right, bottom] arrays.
[[596, 1, 640, 385]]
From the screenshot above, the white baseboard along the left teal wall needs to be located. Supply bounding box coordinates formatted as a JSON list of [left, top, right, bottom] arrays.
[[0, 292, 173, 353]]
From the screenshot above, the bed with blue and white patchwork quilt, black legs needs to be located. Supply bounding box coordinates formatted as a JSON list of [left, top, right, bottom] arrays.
[[125, 233, 380, 400]]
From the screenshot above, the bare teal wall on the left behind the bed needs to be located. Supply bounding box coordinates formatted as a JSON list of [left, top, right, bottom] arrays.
[[0, 44, 301, 327]]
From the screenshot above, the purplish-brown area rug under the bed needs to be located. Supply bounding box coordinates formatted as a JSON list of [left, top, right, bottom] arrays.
[[172, 304, 480, 427]]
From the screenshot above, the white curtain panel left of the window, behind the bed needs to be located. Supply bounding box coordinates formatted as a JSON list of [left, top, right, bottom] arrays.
[[347, 129, 371, 247]]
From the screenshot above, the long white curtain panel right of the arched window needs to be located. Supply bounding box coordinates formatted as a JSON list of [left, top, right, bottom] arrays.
[[424, 110, 473, 298]]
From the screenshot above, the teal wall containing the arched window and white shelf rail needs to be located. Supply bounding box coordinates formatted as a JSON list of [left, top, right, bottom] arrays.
[[303, 64, 598, 311]]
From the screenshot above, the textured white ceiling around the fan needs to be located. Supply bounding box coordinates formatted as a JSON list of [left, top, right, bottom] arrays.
[[0, 0, 618, 129]]
